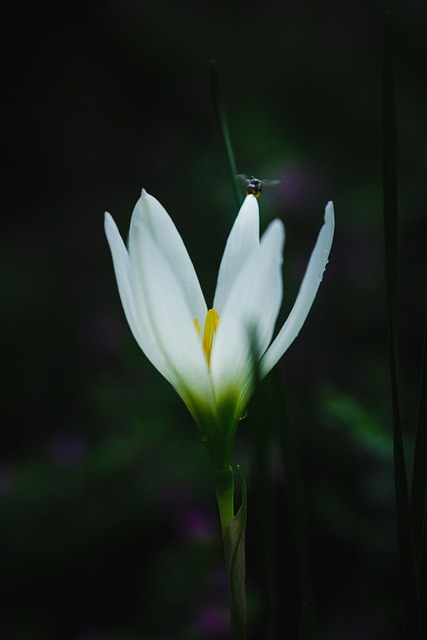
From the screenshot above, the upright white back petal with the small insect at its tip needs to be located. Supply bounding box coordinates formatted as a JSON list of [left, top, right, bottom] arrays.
[[213, 195, 259, 315]]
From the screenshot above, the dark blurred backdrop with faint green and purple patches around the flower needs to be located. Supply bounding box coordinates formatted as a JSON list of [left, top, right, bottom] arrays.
[[0, 0, 427, 640]]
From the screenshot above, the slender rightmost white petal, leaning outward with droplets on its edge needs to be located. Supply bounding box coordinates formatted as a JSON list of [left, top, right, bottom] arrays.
[[261, 202, 335, 376]]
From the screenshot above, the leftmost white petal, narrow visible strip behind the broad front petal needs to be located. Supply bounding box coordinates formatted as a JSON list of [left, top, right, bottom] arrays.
[[105, 212, 180, 382]]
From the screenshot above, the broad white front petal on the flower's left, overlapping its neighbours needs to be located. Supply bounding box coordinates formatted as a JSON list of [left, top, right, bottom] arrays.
[[131, 222, 216, 403]]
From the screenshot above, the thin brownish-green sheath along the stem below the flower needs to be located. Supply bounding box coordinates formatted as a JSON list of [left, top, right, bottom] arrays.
[[224, 466, 247, 640]]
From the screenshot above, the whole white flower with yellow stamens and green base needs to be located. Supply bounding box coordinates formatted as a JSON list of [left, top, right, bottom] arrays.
[[105, 190, 334, 468]]
